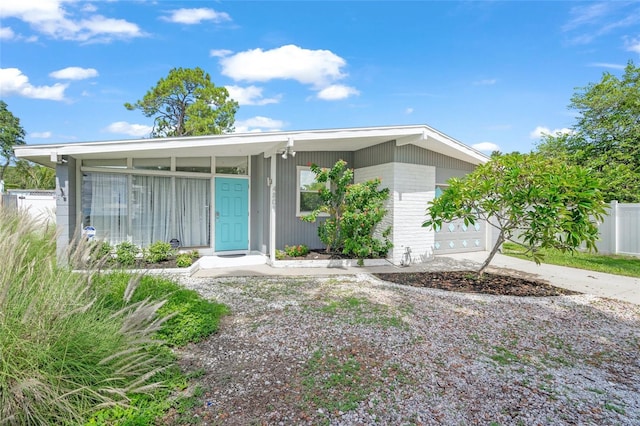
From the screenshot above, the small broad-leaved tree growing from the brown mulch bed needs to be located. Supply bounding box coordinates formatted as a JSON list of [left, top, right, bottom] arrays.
[[423, 153, 606, 276]]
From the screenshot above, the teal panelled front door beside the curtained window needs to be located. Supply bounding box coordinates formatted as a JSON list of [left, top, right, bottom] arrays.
[[215, 177, 249, 251]]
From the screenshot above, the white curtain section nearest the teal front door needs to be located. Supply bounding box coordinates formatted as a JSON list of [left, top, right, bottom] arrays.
[[176, 178, 211, 247]]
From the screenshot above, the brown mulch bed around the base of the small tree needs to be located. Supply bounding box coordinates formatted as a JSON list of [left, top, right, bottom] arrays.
[[374, 271, 580, 297]]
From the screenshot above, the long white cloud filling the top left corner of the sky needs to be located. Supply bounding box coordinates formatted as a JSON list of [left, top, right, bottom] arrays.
[[0, 0, 144, 42]]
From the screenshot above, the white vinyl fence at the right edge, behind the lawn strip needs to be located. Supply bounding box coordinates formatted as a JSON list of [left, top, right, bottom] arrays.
[[596, 201, 640, 256]]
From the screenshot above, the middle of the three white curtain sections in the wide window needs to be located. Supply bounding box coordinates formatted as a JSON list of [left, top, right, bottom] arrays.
[[131, 175, 172, 247]]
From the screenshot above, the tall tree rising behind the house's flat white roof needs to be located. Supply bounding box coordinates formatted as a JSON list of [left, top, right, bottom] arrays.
[[124, 68, 238, 137]]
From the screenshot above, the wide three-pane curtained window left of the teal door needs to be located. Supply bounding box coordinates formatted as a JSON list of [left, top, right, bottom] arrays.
[[82, 172, 211, 247]]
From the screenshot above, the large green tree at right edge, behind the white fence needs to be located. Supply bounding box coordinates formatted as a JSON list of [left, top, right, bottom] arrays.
[[537, 62, 640, 203]]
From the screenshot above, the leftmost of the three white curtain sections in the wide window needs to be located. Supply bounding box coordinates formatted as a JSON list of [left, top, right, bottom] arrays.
[[83, 173, 128, 244]]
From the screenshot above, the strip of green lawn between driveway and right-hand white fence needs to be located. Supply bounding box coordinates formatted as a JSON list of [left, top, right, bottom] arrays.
[[502, 243, 640, 278]]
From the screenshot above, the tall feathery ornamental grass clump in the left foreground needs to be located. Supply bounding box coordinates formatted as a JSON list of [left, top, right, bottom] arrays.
[[0, 208, 171, 425]]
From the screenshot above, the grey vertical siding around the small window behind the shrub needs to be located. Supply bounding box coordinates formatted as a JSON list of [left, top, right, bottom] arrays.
[[275, 151, 353, 250]]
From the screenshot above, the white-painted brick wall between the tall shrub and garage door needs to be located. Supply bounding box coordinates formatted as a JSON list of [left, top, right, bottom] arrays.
[[354, 163, 436, 264]]
